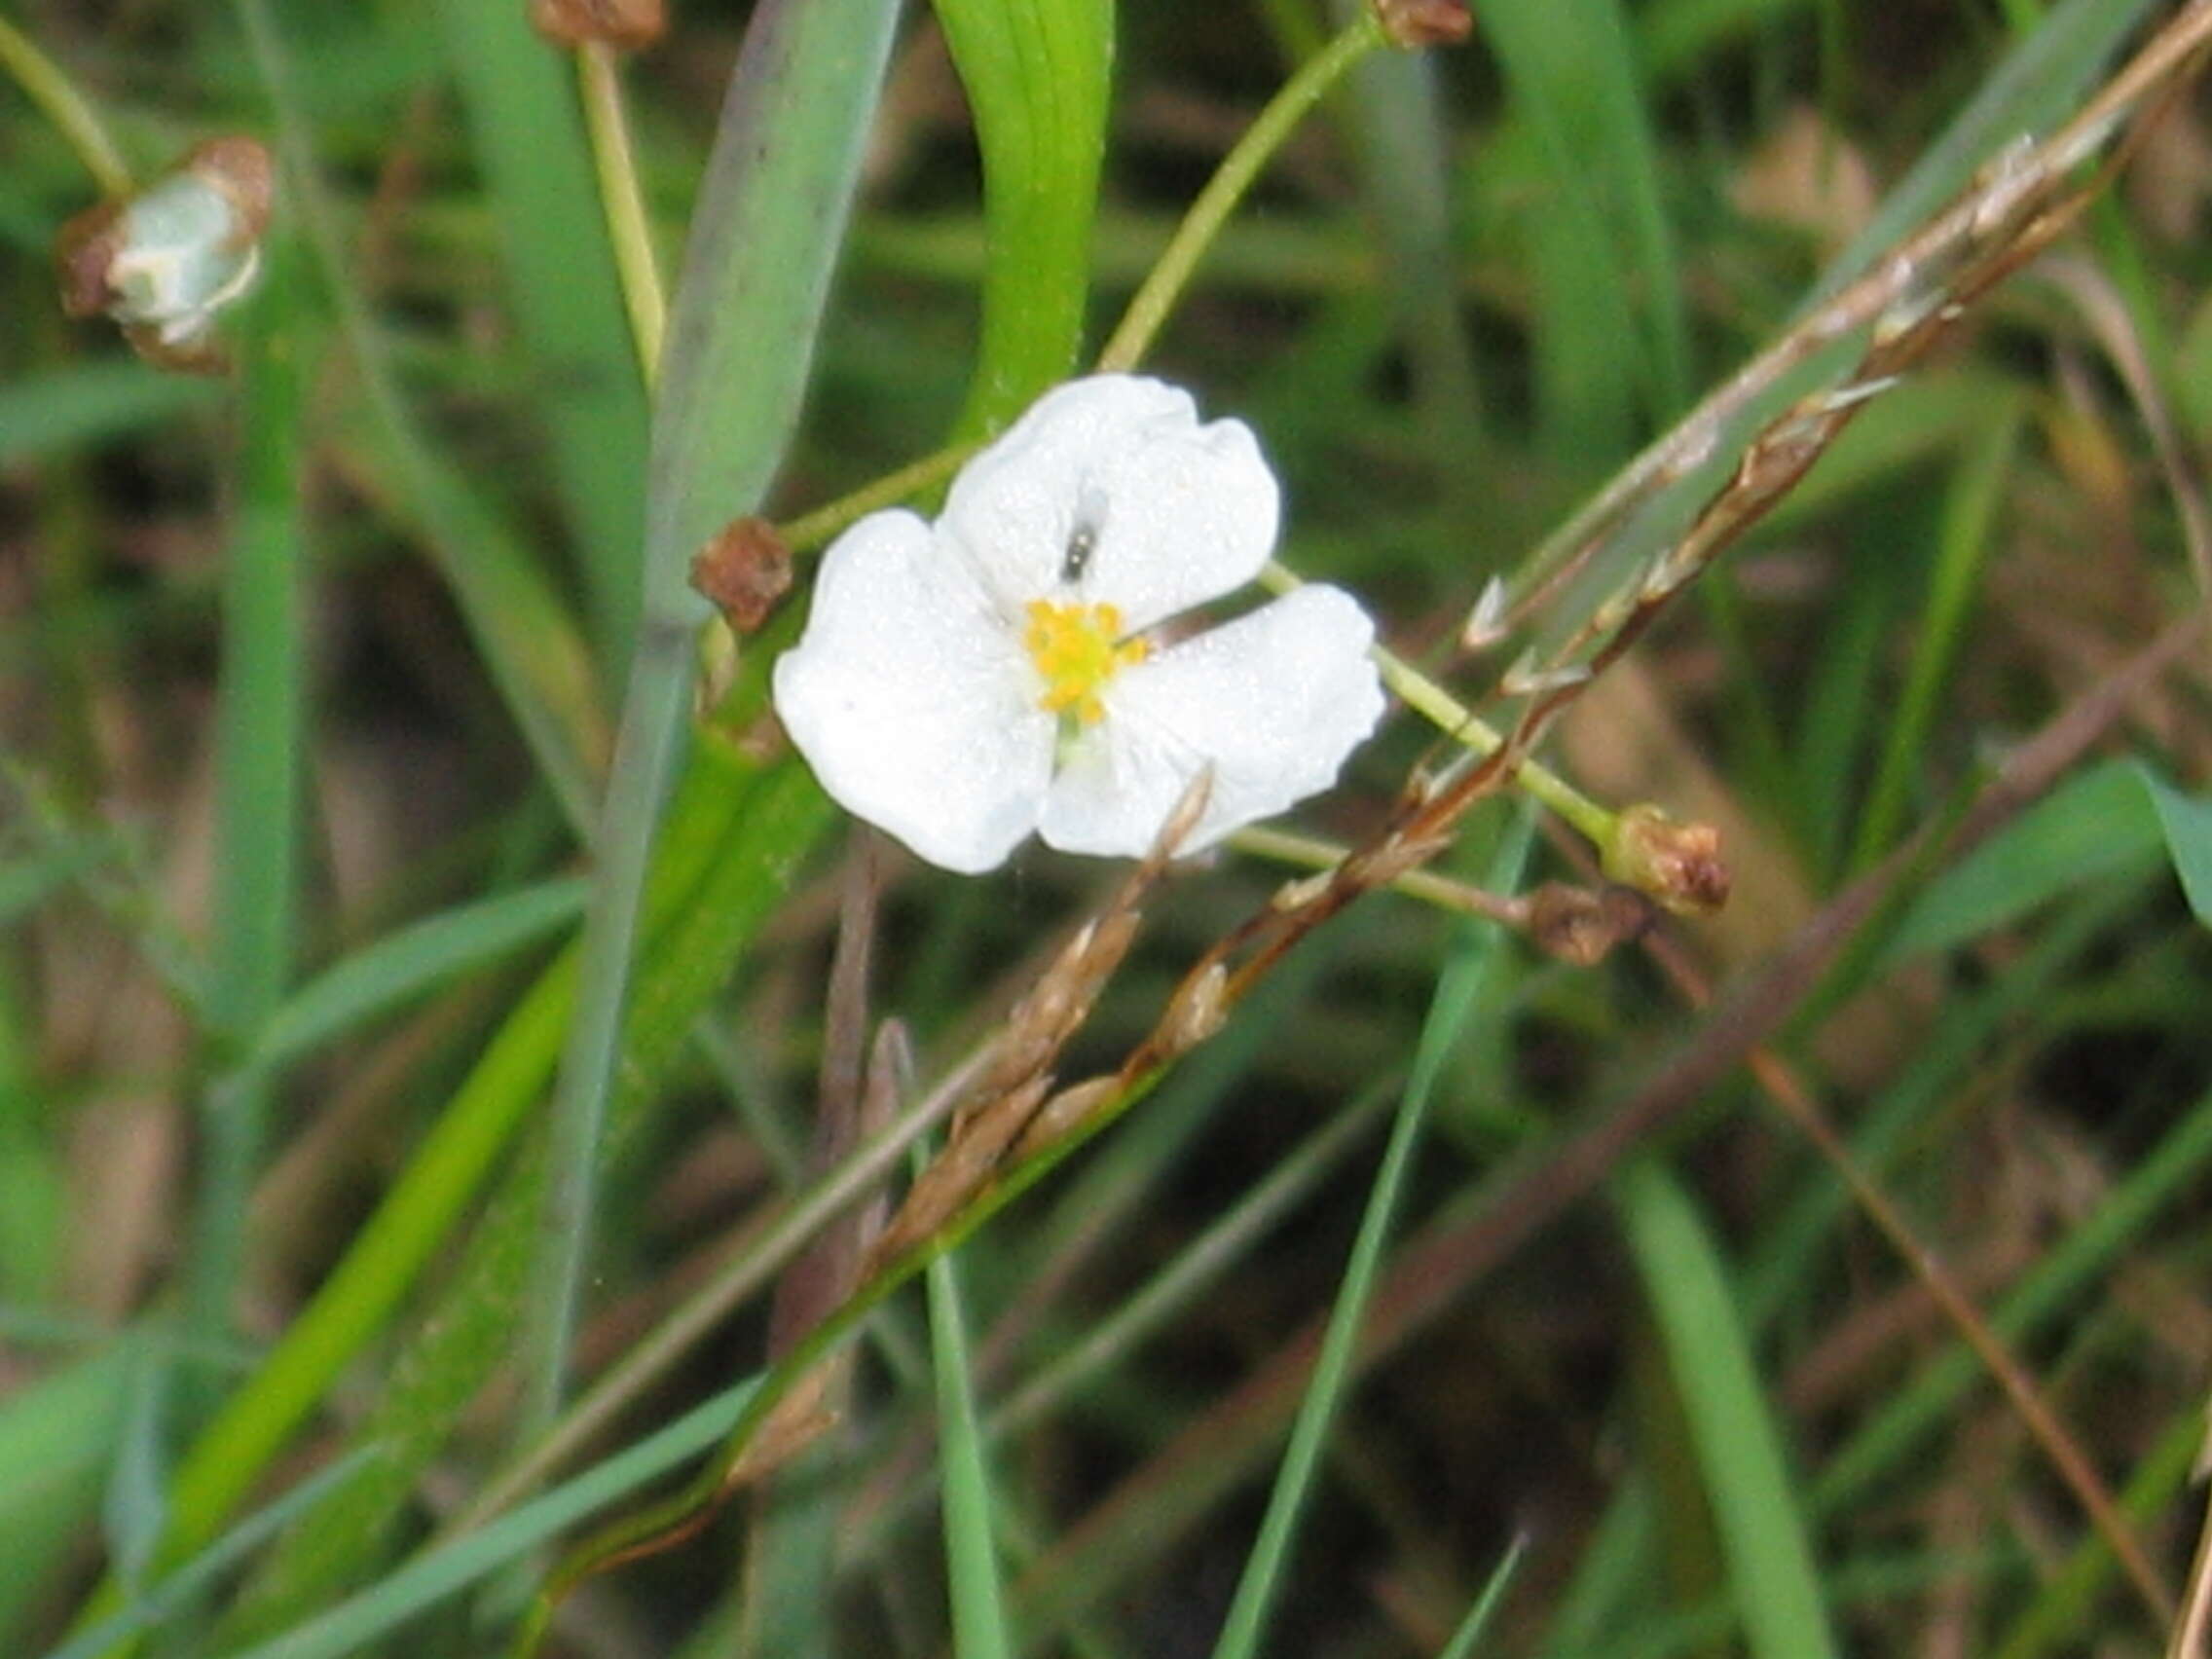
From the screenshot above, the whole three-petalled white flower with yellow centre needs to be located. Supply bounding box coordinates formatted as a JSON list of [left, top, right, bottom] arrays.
[[774, 374, 1382, 873]]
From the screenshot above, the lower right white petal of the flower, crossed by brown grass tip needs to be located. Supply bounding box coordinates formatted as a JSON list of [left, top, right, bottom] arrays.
[[1040, 586, 1382, 854]]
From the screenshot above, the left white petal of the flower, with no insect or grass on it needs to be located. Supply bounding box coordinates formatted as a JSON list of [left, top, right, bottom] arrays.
[[774, 513, 1055, 873]]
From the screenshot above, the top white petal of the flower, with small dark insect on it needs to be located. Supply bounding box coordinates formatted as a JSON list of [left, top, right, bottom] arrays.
[[938, 374, 1280, 631]]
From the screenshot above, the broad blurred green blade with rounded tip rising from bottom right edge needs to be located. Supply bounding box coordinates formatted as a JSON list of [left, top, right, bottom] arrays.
[[1617, 1163, 1838, 1659]]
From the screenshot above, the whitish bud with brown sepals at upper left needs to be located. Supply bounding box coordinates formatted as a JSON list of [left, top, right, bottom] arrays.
[[55, 137, 272, 374]]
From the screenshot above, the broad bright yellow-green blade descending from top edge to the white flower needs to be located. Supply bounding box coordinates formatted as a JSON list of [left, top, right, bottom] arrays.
[[936, 0, 1113, 433]]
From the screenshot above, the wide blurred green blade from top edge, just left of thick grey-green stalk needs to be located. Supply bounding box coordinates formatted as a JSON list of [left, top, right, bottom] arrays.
[[436, 5, 645, 664]]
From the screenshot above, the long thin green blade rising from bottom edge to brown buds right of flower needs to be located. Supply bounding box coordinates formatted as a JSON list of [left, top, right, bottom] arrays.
[[1214, 816, 1530, 1659]]
